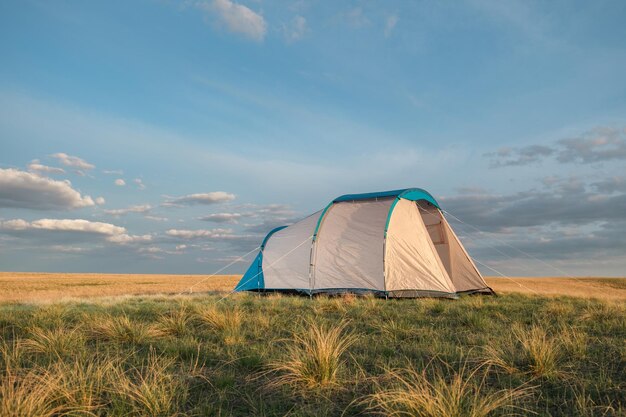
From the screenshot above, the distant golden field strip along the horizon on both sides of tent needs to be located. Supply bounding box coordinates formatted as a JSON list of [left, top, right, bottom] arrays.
[[0, 272, 626, 302]]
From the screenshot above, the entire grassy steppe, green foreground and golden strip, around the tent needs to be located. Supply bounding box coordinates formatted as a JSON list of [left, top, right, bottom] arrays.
[[0, 273, 626, 417]]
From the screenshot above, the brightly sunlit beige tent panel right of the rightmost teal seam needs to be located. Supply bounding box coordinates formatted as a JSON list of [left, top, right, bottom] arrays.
[[385, 199, 455, 293]]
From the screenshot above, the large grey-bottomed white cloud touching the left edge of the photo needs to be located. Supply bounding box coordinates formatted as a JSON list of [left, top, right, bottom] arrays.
[[0, 168, 94, 210]]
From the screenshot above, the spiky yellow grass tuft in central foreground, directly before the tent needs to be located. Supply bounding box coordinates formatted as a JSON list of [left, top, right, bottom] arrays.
[[269, 322, 356, 388]]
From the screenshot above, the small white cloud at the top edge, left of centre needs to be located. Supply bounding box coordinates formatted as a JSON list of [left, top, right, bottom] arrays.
[[196, 0, 267, 41]]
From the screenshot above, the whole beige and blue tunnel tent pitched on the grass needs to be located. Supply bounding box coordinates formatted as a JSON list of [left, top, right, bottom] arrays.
[[235, 188, 493, 298]]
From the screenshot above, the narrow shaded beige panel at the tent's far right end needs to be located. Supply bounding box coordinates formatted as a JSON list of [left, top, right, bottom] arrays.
[[441, 216, 487, 291]]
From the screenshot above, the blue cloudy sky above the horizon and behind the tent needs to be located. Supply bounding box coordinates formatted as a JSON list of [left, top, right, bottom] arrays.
[[0, 0, 626, 276]]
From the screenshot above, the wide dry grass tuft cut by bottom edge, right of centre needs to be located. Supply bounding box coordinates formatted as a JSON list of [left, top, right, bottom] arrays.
[[365, 362, 533, 417]]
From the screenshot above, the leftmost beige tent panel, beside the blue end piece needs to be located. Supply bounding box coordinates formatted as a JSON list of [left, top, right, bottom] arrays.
[[263, 211, 321, 289]]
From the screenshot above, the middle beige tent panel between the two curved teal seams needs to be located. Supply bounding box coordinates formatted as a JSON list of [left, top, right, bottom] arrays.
[[313, 198, 393, 290]]
